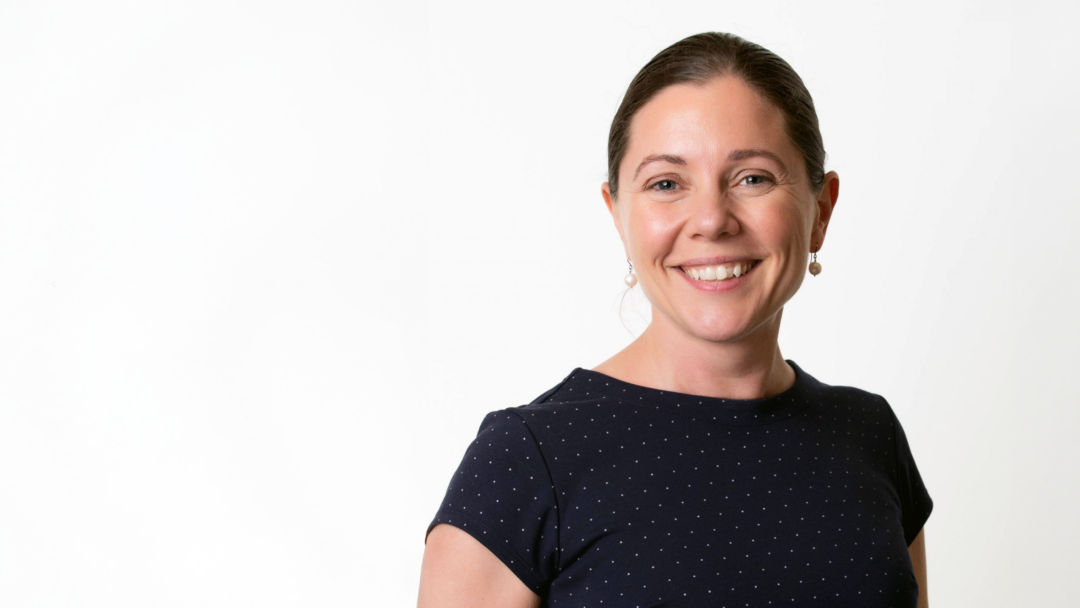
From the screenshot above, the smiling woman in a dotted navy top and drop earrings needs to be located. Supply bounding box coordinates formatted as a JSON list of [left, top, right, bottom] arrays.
[[419, 32, 933, 607]]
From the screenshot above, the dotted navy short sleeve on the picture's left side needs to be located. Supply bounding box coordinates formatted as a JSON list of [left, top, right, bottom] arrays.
[[424, 408, 558, 595]]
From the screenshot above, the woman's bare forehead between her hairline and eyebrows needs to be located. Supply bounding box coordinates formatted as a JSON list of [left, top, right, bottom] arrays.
[[623, 76, 799, 172]]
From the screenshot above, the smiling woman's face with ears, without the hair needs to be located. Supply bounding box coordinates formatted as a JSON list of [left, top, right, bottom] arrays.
[[603, 77, 839, 341]]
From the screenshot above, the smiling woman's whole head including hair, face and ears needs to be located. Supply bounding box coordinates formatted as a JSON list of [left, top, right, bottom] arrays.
[[602, 33, 839, 341]]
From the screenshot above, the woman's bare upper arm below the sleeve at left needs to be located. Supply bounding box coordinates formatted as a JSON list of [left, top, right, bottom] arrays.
[[417, 524, 544, 608]]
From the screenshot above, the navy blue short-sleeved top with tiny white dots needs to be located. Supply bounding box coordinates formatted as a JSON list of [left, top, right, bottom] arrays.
[[424, 360, 933, 608]]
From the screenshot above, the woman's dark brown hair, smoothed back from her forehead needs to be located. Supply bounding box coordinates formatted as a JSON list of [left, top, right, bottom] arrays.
[[608, 31, 825, 197]]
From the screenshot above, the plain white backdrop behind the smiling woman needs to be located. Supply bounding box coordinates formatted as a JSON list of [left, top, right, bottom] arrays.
[[0, 0, 1080, 608]]
